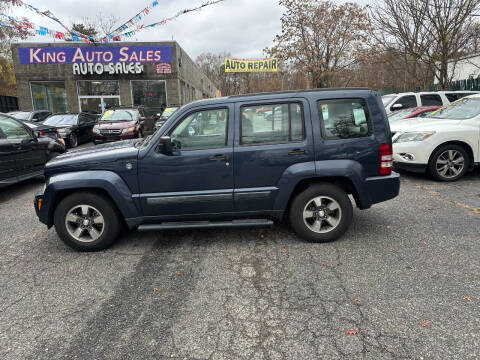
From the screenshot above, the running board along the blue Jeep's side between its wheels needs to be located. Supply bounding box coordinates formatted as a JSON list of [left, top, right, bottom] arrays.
[[138, 219, 273, 231]]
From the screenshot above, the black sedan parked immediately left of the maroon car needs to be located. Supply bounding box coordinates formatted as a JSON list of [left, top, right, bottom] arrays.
[[43, 112, 96, 148]]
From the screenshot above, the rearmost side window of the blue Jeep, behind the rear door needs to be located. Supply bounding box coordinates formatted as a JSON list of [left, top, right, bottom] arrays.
[[317, 99, 371, 139]]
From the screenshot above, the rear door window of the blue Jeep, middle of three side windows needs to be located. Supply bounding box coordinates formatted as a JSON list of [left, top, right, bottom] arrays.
[[240, 103, 304, 145]]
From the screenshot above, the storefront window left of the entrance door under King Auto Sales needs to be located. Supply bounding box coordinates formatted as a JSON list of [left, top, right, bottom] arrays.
[[30, 81, 67, 112]]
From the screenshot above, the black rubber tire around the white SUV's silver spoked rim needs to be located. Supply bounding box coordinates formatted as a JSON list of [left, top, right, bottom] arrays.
[[428, 144, 470, 182]]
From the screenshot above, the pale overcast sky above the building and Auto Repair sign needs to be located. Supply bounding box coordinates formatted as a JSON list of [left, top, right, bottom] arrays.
[[11, 0, 369, 59]]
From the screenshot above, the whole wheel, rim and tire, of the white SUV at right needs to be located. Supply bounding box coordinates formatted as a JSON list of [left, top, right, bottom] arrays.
[[428, 144, 470, 181]]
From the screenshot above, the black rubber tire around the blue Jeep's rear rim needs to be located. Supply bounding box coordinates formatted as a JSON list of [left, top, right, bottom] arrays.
[[289, 184, 353, 243]]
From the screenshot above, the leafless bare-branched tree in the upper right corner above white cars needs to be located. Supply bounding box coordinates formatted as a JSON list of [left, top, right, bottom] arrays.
[[371, 0, 480, 89]]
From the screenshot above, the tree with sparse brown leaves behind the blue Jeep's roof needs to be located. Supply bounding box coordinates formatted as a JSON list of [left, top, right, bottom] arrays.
[[265, 0, 370, 87]]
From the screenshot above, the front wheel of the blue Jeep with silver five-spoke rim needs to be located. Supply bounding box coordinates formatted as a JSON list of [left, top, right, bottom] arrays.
[[54, 192, 121, 251]]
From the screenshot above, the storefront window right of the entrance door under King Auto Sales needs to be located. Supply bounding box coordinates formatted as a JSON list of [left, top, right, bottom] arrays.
[[132, 80, 167, 114]]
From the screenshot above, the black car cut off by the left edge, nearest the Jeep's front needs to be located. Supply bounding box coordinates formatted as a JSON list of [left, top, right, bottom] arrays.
[[0, 114, 65, 187]]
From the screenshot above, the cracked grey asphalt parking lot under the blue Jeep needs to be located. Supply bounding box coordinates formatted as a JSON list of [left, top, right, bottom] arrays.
[[0, 142, 480, 359]]
